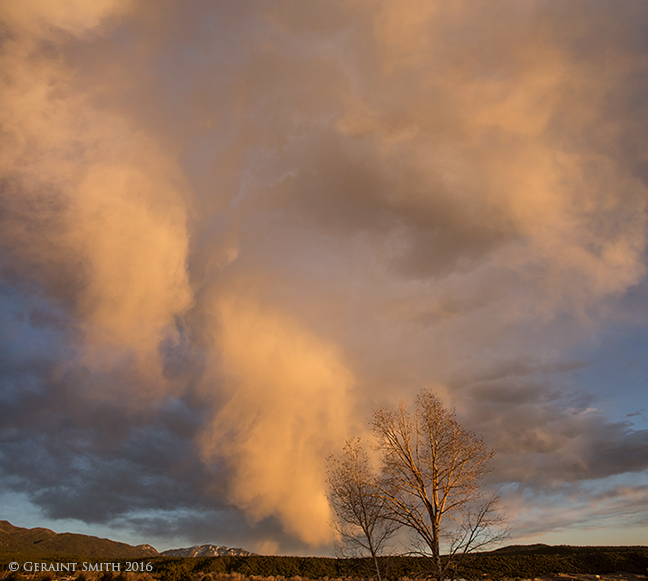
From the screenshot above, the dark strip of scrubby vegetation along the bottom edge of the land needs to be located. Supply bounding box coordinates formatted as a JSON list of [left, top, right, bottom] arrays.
[[0, 545, 648, 581]]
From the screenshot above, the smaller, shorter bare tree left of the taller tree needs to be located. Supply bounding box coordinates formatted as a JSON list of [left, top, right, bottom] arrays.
[[327, 438, 401, 581]]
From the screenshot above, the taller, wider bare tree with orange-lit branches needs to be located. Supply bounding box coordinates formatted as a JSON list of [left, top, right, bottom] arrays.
[[372, 390, 507, 581]]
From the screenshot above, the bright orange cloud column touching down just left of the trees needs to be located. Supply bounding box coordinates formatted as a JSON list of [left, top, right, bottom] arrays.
[[201, 297, 353, 545]]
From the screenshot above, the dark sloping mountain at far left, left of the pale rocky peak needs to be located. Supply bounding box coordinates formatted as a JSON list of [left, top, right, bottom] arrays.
[[0, 520, 159, 559]]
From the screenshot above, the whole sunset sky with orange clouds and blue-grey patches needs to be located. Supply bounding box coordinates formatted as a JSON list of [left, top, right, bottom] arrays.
[[0, 0, 648, 555]]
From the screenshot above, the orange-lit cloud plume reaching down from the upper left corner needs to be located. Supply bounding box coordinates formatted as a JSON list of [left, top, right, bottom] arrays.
[[3, 2, 191, 386]]
